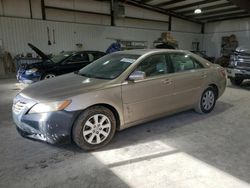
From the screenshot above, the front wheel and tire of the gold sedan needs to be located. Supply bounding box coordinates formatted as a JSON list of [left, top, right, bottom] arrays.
[[72, 106, 116, 151]]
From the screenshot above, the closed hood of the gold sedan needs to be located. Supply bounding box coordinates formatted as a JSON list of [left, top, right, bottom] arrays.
[[21, 73, 112, 102]]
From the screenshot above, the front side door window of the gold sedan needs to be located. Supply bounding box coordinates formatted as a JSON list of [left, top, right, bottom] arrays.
[[136, 54, 169, 77]]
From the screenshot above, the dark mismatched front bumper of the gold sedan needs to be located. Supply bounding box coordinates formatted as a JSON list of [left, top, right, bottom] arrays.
[[12, 95, 80, 144]]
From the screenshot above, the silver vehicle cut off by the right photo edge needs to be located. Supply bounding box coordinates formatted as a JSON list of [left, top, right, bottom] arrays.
[[227, 47, 250, 85]]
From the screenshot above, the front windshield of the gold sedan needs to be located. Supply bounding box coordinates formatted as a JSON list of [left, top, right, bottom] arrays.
[[78, 54, 140, 79]]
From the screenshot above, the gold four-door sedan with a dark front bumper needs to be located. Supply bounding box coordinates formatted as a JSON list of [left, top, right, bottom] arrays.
[[12, 50, 226, 150]]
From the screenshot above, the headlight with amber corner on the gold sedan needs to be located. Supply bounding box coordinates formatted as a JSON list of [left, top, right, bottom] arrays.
[[29, 100, 71, 114]]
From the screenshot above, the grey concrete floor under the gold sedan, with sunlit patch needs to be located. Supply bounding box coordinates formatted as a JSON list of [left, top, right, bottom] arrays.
[[0, 80, 250, 188]]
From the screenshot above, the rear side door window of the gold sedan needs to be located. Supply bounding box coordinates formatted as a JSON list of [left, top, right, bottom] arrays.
[[169, 53, 203, 72]]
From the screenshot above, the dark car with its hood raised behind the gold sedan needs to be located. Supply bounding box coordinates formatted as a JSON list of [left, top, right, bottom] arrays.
[[17, 43, 105, 84]]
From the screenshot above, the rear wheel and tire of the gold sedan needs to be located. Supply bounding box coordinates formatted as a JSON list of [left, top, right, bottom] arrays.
[[195, 87, 217, 114]]
